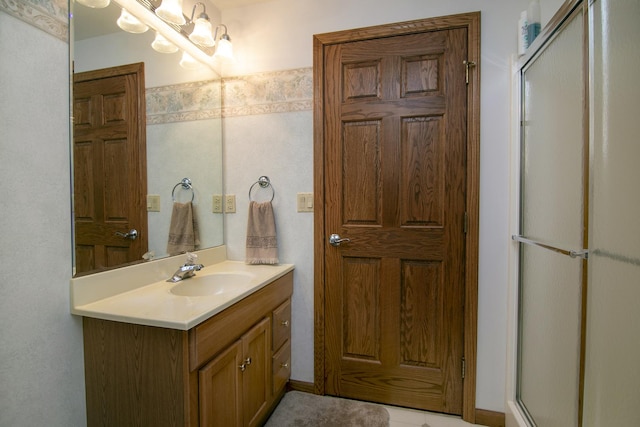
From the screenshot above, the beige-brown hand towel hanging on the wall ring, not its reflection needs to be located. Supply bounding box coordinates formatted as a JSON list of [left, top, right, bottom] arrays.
[[246, 201, 279, 264]]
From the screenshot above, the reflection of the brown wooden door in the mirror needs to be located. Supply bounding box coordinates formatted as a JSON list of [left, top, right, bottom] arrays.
[[73, 63, 148, 275]]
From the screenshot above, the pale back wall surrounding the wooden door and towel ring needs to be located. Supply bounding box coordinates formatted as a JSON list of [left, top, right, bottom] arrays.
[[222, 0, 562, 412]]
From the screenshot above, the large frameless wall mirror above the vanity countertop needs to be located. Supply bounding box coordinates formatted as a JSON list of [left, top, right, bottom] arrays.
[[70, 1, 223, 275]]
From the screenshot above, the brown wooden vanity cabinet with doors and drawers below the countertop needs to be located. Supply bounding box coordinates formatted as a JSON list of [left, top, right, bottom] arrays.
[[83, 272, 293, 427]]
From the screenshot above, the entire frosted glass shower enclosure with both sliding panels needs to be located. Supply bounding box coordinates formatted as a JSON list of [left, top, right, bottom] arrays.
[[512, 0, 640, 427]]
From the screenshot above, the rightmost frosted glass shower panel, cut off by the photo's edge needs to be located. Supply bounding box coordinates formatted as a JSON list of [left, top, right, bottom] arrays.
[[584, 0, 640, 427]]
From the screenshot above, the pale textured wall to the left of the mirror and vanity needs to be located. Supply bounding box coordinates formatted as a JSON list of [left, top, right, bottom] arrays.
[[0, 1, 86, 427]]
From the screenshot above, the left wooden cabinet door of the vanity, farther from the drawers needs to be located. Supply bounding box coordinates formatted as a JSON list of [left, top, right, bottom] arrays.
[[199, 340, 243, 426]]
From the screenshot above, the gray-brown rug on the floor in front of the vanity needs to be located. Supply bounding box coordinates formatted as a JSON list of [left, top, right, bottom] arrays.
[[265, 391, 389, 427]]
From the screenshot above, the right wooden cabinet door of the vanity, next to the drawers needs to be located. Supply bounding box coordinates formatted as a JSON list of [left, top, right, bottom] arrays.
[[240, 317, 271, 427]]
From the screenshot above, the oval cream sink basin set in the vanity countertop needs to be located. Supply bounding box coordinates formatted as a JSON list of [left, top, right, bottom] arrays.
[[170, 273, 253, 297]]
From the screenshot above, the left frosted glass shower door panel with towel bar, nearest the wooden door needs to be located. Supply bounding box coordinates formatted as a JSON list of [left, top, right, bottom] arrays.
[[514, 8, 586, 427]]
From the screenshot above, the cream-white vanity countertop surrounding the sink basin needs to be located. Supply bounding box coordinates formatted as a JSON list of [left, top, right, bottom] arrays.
[[71, 247, 294, 330]]
